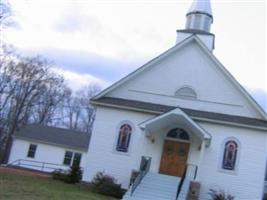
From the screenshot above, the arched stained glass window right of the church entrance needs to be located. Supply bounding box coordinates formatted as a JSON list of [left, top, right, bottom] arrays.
[[222, 140, 238, 170]]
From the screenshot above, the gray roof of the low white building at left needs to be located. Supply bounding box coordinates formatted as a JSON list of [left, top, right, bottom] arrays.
[[14, 124, 91, 151]]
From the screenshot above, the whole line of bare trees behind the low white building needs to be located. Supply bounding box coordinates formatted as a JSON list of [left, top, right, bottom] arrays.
[[0, 46, 100, 162]]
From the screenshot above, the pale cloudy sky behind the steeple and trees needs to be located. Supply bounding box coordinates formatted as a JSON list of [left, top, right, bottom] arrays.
[[2, 0, 267, 110]]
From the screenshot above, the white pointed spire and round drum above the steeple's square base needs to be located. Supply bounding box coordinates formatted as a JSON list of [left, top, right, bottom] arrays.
[[186, 0, 213, 32]]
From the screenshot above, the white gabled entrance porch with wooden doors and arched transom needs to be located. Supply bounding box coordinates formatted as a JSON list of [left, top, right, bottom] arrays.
[[139, 108, 211, 179]]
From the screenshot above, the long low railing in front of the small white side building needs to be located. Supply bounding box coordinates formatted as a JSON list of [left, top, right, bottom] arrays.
[[7, 159, 68, 172]]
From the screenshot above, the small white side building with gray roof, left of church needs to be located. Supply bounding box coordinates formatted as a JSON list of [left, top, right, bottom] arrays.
[[8, 124, 90, 172]]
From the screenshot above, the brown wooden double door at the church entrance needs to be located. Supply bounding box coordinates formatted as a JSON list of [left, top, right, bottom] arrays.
[[159, 140, 190, 177]]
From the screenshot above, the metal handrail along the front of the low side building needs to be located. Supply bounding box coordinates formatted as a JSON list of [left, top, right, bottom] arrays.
[[7, 159, 67, 171]]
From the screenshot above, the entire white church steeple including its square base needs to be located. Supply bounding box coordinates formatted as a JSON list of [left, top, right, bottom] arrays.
[[176, 0, 215, 51]]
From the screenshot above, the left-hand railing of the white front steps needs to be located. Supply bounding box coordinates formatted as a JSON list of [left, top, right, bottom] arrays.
[[131, 156, 151, 196]]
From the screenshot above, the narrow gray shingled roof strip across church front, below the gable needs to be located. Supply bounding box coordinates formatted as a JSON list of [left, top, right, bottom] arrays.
[[93, 97, 267, 128]]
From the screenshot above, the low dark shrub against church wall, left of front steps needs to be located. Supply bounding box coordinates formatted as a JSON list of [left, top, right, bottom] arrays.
[[91, 172, 125, 199]]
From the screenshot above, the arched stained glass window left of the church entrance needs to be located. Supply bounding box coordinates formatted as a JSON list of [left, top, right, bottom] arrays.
[[116, 124, 132, 152]]
